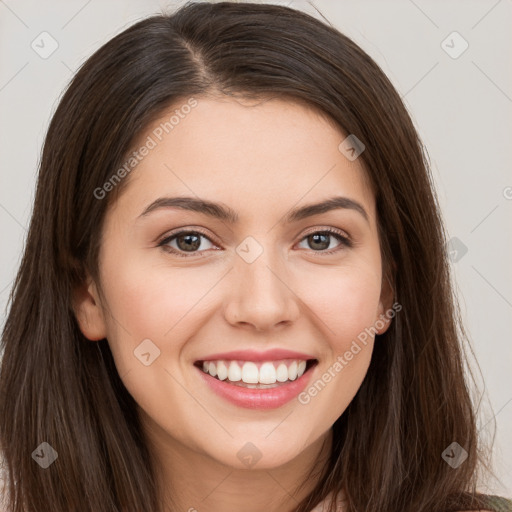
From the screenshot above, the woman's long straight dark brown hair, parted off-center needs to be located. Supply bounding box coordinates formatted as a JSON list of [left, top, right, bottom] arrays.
[[0, 2, 500, 512]]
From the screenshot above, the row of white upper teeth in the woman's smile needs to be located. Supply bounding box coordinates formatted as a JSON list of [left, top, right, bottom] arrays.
[[203, 360, 312, 384]]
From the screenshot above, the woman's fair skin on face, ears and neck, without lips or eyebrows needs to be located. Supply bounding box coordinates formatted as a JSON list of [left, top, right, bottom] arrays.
[[75, 97, 392, 512]]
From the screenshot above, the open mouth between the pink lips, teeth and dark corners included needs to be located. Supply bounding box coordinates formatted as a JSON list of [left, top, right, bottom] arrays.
[[194, 359, 318, 389]]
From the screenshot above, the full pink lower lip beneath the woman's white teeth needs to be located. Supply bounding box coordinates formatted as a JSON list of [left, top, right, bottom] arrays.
[[197, 365, 316, 409]]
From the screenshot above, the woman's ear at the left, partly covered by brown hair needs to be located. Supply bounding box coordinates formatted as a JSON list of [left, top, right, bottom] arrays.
[[73, 276, 107, 341]]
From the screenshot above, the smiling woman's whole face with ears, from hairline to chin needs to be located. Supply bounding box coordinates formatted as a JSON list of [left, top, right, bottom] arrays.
[[75, 97, 391, 468]]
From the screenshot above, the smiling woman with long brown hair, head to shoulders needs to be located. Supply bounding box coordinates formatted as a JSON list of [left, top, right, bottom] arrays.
[[0, 2, 504, 512]]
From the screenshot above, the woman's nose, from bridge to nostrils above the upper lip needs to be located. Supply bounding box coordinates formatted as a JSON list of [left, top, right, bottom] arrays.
[[224, 250, 300, 331]]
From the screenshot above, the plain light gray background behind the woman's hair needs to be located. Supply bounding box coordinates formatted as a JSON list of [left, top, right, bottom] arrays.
[[0, 0, 512, 496]]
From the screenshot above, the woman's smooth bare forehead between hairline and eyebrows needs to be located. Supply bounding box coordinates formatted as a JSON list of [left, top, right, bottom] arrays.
[[113, 97, 374, 224]]
